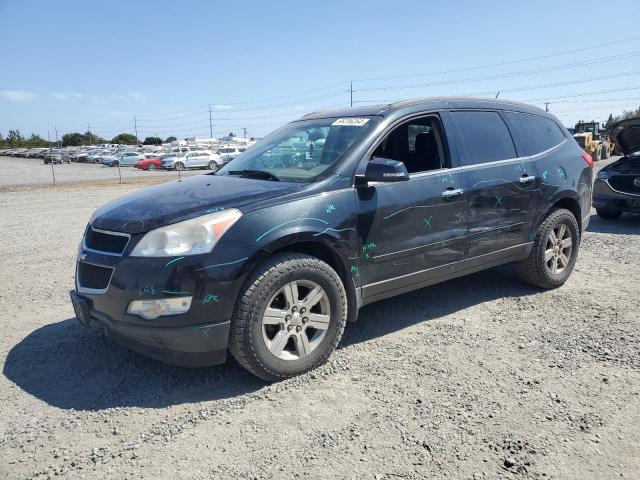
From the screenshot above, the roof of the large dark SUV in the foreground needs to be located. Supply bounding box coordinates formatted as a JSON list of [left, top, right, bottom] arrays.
[[300, 97, 548, 120]]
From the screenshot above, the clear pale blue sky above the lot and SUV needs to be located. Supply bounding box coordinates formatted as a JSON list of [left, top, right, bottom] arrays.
[[0, 0, 640, 139]]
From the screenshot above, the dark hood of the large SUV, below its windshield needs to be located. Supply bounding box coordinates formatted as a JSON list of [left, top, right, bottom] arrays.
[[91, 175, 303, 234]]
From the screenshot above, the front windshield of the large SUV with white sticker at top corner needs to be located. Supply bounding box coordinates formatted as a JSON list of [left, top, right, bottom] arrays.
[[216, 117, 378, 182]]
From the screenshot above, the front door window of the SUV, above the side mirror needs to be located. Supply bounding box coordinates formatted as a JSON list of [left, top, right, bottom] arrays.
[[371, 115, 449, 174]]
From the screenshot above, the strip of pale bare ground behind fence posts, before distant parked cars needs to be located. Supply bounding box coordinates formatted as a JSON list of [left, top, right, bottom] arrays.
[[0, 156, 200, 191]]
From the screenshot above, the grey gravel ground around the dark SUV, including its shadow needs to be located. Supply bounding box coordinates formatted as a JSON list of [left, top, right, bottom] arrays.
[[0, 159, 640, 480]]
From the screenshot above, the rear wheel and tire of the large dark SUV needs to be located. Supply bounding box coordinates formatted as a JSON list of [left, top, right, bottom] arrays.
[[516, 208, 580, 289]]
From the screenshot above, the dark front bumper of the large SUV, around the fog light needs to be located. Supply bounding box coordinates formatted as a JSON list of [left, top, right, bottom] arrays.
[[71, 235, 246, 367]]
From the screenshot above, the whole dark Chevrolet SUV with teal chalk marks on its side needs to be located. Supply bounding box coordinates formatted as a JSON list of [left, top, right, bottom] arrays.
[[71, 98, 593, 381]]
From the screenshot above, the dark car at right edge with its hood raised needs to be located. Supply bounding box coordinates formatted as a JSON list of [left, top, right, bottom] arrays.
[[593, 118, 640, 219]]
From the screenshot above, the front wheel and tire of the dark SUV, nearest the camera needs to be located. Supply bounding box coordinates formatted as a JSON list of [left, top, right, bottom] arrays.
[[229, 252, 347, 382]]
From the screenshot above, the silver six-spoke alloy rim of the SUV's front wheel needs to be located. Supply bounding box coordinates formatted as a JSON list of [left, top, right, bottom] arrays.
[[262, 280, 331, 360]]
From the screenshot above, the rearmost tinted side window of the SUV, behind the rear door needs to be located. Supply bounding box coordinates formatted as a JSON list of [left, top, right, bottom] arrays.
[[505, 112, 565, 157]]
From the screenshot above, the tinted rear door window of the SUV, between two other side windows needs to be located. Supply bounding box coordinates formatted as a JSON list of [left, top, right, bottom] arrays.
[[451, 112, 516, 165]]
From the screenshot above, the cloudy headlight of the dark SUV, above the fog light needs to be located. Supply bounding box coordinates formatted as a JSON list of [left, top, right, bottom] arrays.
[[131, 208, 242, 257]]
